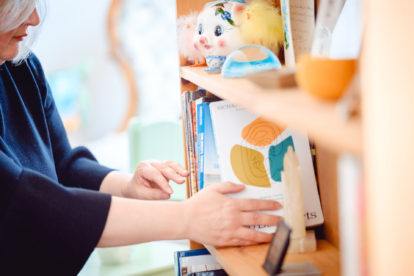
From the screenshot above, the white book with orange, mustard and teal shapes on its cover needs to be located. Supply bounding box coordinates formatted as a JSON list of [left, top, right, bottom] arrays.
[[210, 101, 324, 232]]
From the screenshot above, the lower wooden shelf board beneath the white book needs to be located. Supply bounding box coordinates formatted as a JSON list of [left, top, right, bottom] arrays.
[[206, 240, 340, 276]]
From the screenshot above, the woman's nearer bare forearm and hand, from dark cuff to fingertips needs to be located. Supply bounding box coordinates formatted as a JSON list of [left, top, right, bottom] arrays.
[[98, 181, 280, 247]]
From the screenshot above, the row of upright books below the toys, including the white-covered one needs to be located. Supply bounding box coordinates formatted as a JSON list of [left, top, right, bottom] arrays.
[[182, 90, 323, 232]]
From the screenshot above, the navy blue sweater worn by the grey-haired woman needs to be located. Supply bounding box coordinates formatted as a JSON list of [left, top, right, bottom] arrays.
[[0, 54, 111, 275]]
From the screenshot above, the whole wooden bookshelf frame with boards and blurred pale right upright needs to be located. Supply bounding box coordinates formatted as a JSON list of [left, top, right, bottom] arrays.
[[176, 0, 414, 275]]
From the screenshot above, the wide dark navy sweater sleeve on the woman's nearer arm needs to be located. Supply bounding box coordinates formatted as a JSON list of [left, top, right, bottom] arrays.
[[0, 152, 111, 275]]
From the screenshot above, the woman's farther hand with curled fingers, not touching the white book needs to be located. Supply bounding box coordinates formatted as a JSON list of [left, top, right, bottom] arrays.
[[122, 161, 188, 199]]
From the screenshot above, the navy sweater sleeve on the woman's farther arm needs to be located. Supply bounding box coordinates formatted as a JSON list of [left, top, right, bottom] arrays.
[[28, 54, 112, 191]]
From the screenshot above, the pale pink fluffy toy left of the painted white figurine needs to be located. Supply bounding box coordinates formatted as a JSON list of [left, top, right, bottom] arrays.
[[177, 13, 205, 66]]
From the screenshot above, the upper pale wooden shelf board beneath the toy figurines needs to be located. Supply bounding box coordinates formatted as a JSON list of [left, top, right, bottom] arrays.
[[180, 66, 362, 155]]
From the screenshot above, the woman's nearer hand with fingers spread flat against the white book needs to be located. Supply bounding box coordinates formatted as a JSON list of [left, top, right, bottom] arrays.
[[184, 182, 281, 246]]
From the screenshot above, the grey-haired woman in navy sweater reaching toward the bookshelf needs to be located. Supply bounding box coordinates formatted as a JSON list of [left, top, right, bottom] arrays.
[[0, 0, 280, 275]]
